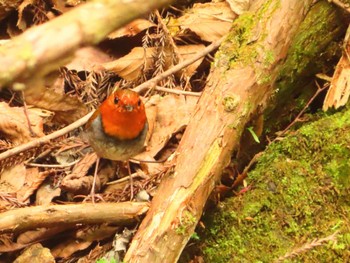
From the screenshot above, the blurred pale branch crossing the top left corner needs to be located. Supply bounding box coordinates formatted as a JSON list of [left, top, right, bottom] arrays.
[[0, 0, 172, 89]]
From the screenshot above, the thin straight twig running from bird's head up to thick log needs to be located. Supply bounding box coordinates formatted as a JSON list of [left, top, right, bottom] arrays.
[[134, 36, 226, 93]]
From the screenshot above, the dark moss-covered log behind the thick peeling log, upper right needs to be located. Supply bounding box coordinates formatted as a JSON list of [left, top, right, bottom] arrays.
[[265, 1, 347, 132]]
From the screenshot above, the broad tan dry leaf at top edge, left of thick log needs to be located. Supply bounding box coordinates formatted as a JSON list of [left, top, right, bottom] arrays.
[[177, 2, 237, 42]]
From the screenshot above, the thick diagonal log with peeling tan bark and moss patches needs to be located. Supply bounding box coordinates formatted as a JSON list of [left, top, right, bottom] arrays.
[[124, 0, 312, 262]]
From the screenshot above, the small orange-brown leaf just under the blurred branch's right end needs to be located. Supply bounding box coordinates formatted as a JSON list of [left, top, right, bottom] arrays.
[[108, 19, 155, 39]]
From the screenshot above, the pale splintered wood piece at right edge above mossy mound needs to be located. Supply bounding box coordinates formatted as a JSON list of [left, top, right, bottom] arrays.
[[323, 26, 350, 111]]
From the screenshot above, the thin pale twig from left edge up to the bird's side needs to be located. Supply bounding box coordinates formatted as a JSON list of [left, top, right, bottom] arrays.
[[0, 112, 92, 160]]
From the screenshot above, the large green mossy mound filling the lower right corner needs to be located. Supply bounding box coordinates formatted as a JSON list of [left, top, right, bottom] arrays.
[[200, 110, 350, 263]]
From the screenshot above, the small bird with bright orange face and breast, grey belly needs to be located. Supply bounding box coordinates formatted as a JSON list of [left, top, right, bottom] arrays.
[[85, 89, 148, 202]]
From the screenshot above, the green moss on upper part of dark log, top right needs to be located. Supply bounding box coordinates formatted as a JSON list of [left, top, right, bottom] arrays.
[[277, 1, 345, 98]]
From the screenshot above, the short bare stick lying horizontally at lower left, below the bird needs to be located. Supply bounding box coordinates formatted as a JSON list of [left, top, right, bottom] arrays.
[[0, 202, 149, 233]]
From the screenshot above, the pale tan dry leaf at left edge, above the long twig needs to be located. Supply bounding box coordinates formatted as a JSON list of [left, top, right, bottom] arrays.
[[0, 102, 44, 144]]
